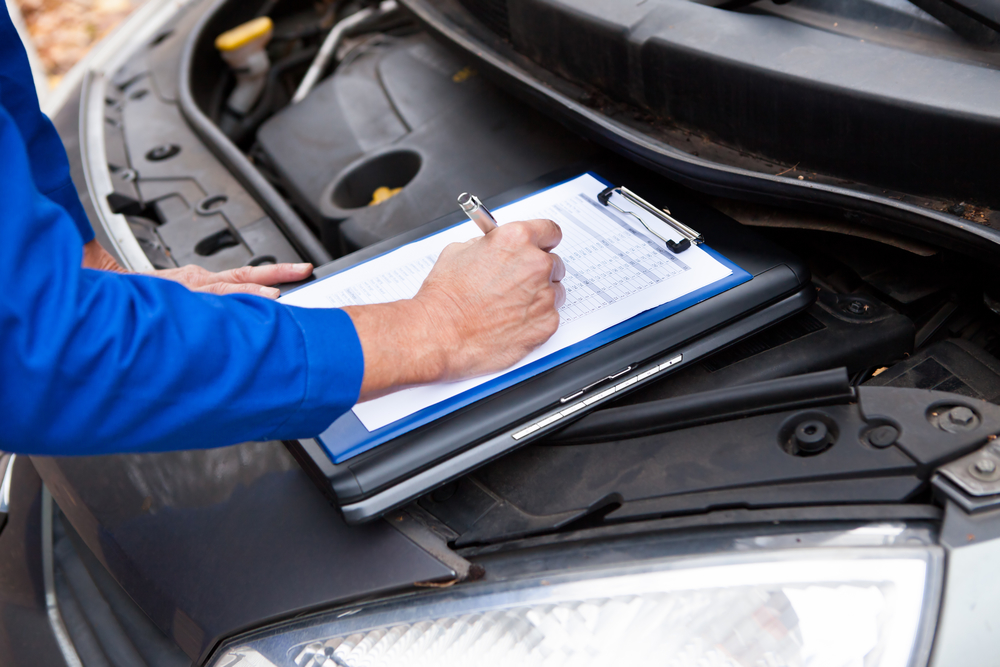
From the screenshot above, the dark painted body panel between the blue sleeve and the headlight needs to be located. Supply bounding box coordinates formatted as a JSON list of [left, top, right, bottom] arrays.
[[32, 442, 452, 662]]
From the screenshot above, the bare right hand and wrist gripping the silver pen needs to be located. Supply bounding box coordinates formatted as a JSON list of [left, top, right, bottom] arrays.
[[344, 220, 566, 399]]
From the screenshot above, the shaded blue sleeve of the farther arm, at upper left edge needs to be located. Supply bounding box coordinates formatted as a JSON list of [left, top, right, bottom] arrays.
[[0, 5, 94, 243]]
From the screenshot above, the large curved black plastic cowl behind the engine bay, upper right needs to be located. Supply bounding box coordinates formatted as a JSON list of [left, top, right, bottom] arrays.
[[402, 0, 1000, 254]]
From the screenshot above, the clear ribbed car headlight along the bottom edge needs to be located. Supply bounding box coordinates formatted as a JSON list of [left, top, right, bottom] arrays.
[[212, 547, 943, 667]]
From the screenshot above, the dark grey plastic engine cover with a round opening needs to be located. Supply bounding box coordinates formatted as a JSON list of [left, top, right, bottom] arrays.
[[257, 35, 596, 254]]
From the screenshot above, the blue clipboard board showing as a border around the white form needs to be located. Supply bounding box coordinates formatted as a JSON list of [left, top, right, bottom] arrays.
[[298, 172, 752, 464]]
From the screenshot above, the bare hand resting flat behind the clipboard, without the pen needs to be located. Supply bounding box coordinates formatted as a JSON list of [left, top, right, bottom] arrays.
[[83, 241, 313, 299]]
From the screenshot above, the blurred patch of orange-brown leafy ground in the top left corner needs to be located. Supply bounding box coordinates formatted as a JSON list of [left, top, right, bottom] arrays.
[[6, 0, 142, 92]]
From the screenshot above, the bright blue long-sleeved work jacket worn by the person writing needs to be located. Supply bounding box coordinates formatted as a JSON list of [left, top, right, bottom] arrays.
[[0, 11, 364, 455]]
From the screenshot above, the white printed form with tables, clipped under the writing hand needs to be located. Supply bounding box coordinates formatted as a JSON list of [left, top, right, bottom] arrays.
[[281, 174, 732, 431]]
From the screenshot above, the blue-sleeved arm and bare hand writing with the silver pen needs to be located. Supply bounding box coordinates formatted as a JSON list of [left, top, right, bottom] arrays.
[[0, 108, 561, 455]]
